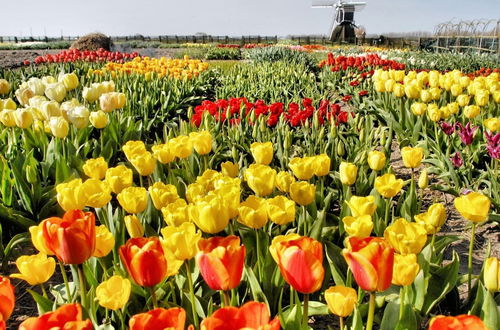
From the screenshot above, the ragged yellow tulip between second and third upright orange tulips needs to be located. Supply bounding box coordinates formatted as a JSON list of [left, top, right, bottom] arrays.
[[161, 222, 201, 260]]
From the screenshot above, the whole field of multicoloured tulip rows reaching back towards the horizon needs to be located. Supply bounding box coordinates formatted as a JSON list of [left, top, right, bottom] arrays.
[[0, 45, 500, 330]]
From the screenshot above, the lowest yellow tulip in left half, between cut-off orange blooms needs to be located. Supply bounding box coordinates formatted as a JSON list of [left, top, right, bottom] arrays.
[[95, 275, 132, 310]]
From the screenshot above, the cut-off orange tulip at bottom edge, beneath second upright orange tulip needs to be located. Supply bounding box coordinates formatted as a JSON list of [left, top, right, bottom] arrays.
[[128, 307, 186, 330]]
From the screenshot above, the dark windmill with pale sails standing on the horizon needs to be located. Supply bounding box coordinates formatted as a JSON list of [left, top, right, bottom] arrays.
[[312, 0, 366, 42]]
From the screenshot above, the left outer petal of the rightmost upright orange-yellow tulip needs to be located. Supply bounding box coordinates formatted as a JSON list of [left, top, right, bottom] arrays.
[[342, 250, 378, 291]]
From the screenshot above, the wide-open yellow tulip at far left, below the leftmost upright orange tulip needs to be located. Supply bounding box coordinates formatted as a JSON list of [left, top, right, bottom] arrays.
[[10, 253, 56, 285]]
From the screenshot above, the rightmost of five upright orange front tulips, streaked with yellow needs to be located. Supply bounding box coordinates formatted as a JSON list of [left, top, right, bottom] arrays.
[[342, 237, 394, 291]]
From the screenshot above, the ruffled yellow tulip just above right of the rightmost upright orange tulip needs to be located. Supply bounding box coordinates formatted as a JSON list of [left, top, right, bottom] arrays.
[[384, 218, 427, 255]]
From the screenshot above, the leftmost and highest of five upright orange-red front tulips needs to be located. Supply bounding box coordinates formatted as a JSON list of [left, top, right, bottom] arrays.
[[43, 210, 96, 265]]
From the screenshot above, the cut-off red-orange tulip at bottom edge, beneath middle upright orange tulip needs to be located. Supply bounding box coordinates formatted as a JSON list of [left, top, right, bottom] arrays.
[[201, 301, 280, 330]]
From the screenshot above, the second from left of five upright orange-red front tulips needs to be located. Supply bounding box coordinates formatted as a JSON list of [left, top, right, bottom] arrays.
[[118, 236, 167, 287]]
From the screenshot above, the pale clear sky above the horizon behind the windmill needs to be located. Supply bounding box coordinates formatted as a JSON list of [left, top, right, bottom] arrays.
[[0, 0, 500, 36]]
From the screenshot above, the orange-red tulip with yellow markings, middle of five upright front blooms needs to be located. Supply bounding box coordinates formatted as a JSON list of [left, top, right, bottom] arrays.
[[196, 235, 246, 291]]
